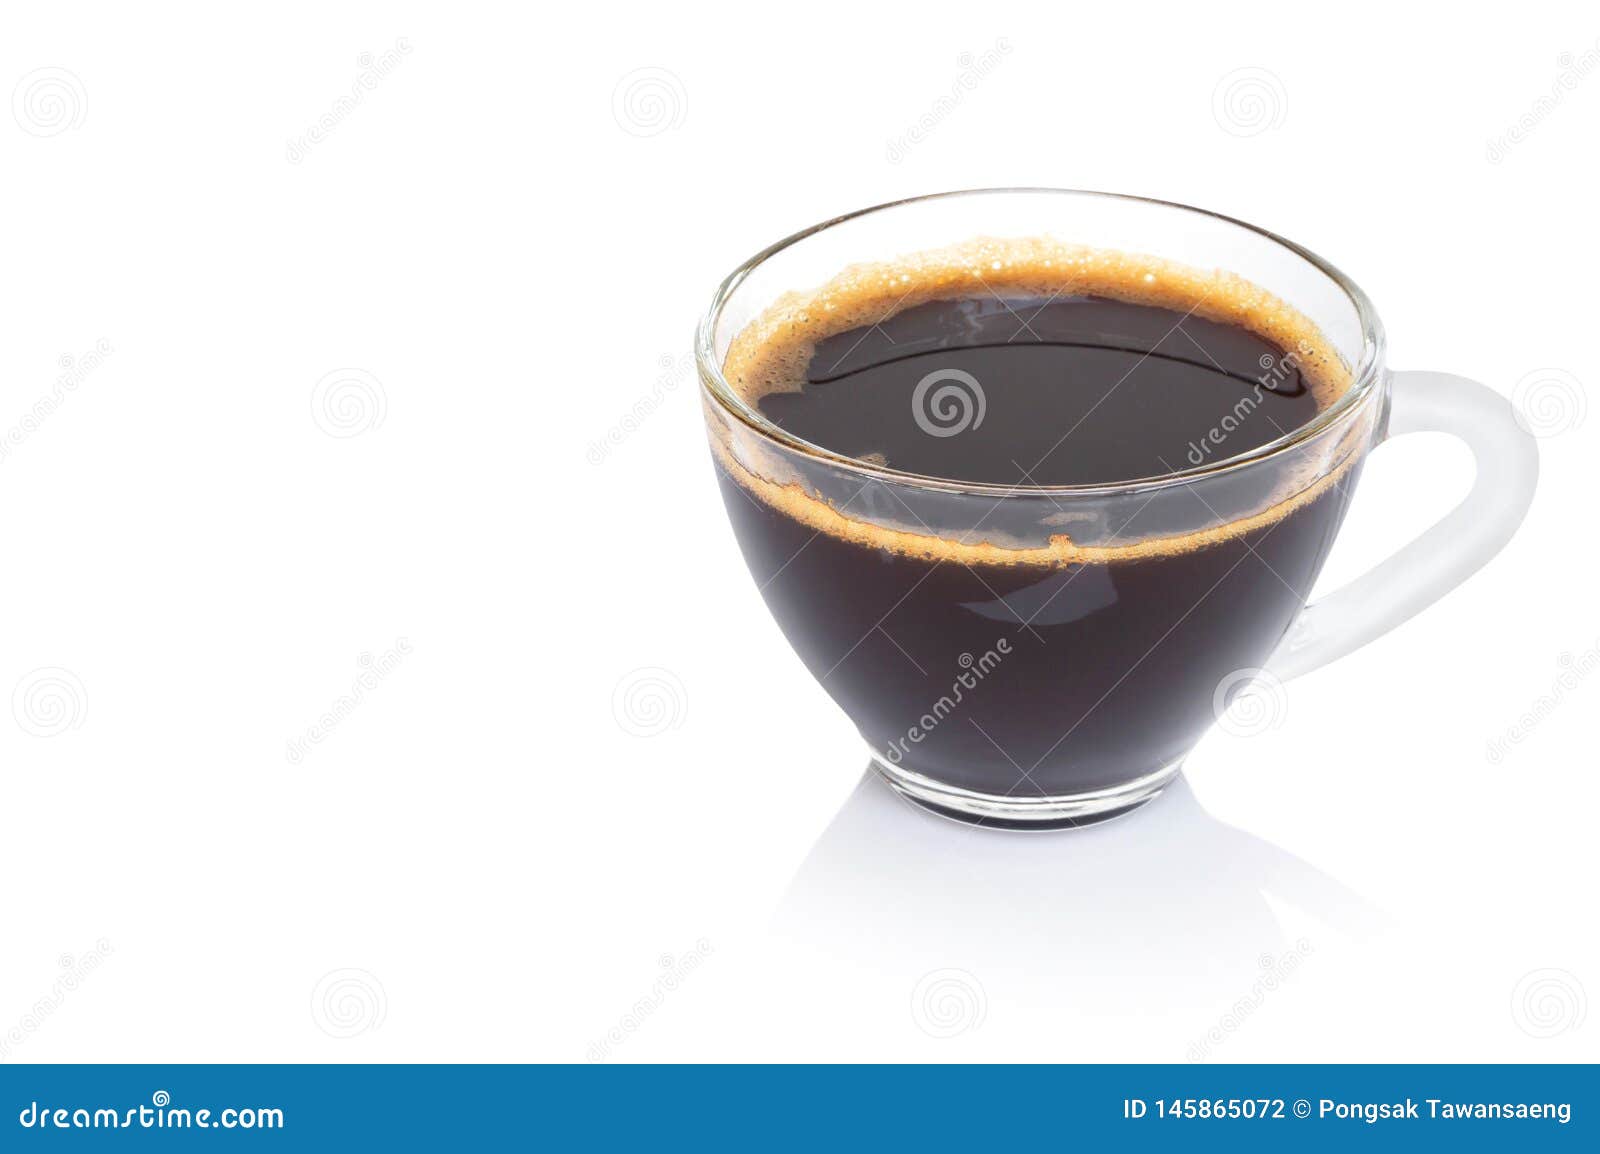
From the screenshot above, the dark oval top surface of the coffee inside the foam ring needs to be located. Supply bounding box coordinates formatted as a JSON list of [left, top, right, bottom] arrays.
[[758, 296, 1317, 485]]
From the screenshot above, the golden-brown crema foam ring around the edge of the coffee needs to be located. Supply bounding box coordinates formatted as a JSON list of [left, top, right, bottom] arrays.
[[706, 237, 1371, 567]]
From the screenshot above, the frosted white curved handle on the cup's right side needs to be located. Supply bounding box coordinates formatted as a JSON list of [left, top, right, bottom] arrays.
[[1267, 373, 1539, 680]]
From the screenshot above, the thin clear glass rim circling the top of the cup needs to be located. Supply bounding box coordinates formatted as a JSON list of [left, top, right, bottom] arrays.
[[694, 186, 1386, 496]]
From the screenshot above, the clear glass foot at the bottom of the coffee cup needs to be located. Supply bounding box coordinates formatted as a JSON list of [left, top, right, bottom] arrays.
[[872, 754, 1182, 831]]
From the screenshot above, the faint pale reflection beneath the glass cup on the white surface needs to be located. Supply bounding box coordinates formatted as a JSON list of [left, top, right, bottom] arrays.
[[773, 771, 1386, 1030]]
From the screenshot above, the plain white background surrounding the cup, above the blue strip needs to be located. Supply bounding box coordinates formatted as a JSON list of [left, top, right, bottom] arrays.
[[0, 2, 1600, 1061]]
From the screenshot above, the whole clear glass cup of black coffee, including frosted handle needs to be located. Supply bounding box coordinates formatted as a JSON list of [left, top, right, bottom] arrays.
[[696, 189, 1538, 829]]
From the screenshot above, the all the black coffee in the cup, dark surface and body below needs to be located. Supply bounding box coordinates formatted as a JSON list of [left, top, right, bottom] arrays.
[[717, 251, 1357, 819]]
